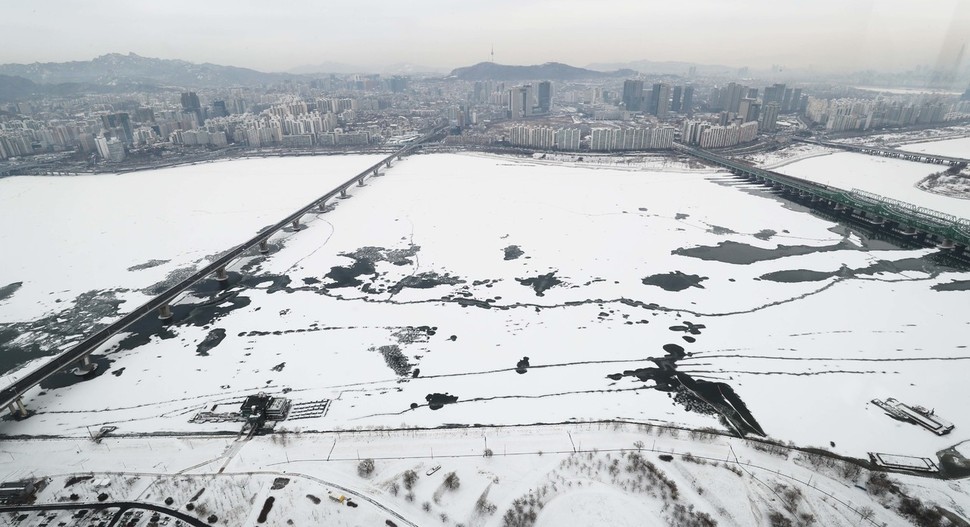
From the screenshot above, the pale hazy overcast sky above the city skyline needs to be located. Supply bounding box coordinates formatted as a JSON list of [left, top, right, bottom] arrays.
[[0, 0, 970, 71]]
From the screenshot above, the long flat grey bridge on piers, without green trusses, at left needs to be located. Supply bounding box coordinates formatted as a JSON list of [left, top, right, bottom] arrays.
[[0, 127, 443, 415]]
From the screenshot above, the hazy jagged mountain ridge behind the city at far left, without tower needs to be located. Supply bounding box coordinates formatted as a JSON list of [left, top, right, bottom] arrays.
[[0, 53, 295, 87]]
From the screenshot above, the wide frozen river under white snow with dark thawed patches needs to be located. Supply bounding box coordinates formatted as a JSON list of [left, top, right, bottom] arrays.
[[0, 148, 970, 462]]
